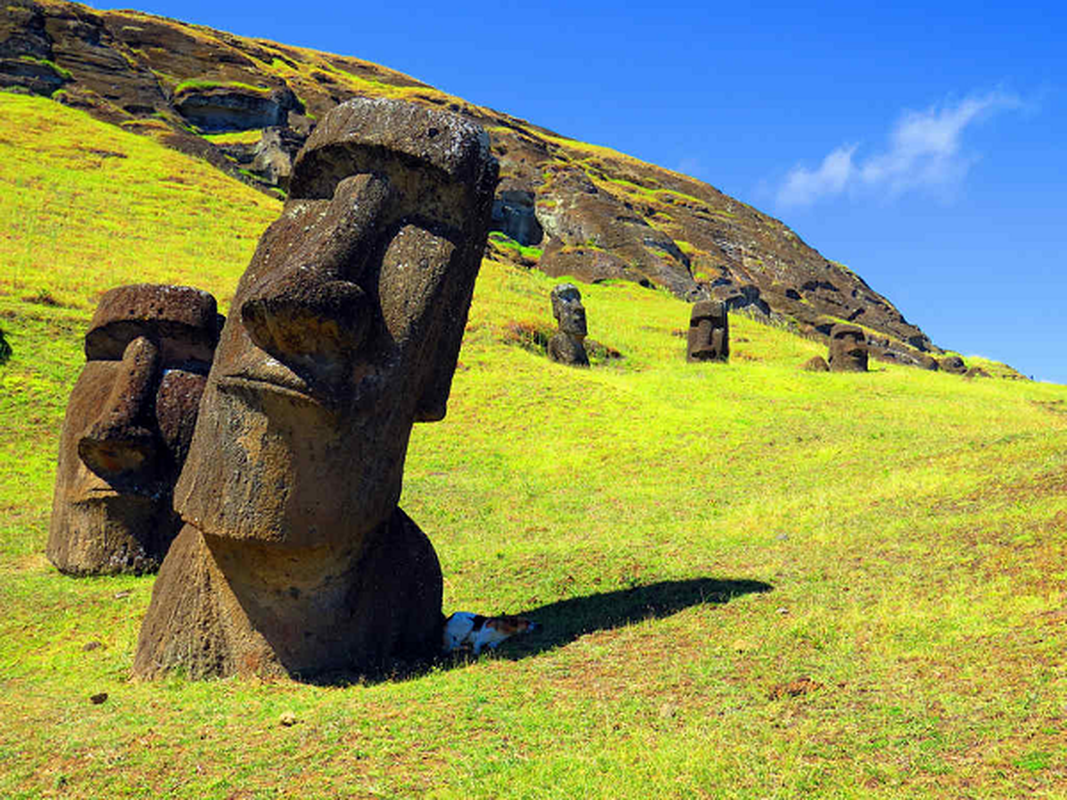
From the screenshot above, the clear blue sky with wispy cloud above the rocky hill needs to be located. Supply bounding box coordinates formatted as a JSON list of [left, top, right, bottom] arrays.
[[104, 0, 1067, 384]]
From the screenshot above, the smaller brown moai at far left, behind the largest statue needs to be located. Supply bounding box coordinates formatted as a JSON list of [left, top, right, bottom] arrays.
[[47, 284, 219, 575]]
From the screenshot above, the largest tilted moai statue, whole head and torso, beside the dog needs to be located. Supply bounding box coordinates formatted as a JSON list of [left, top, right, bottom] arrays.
[[133, 98, 497, 678]]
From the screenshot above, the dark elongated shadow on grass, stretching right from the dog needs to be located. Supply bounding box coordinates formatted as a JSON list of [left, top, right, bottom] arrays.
[[497, 578, 773, 661]]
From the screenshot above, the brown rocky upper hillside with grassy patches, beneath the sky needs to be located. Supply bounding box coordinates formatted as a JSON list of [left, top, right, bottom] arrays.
[[0, 0, 960, 368]]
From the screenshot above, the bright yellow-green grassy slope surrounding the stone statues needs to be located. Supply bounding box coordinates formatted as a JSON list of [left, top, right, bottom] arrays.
[[6, 94, 1067, 798]]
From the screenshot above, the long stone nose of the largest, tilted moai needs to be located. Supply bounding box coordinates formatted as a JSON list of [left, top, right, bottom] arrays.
[[241, 175, 393, 390]]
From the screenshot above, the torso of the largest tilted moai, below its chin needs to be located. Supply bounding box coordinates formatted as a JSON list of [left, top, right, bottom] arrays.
[[133, 509, 444, 679]]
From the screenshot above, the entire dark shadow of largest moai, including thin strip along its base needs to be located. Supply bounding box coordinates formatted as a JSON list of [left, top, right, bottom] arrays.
[[305, 578, 774, 687]]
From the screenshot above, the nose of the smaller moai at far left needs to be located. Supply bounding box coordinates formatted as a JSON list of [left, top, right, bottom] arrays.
[[78, 336, 160, 479]]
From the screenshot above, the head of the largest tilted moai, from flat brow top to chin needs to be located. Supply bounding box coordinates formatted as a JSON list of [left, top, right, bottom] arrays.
[[169, 100, 496, 546]]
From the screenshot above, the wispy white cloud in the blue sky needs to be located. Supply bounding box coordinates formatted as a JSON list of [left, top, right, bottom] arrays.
[[777, 92, 1022, 206]]
